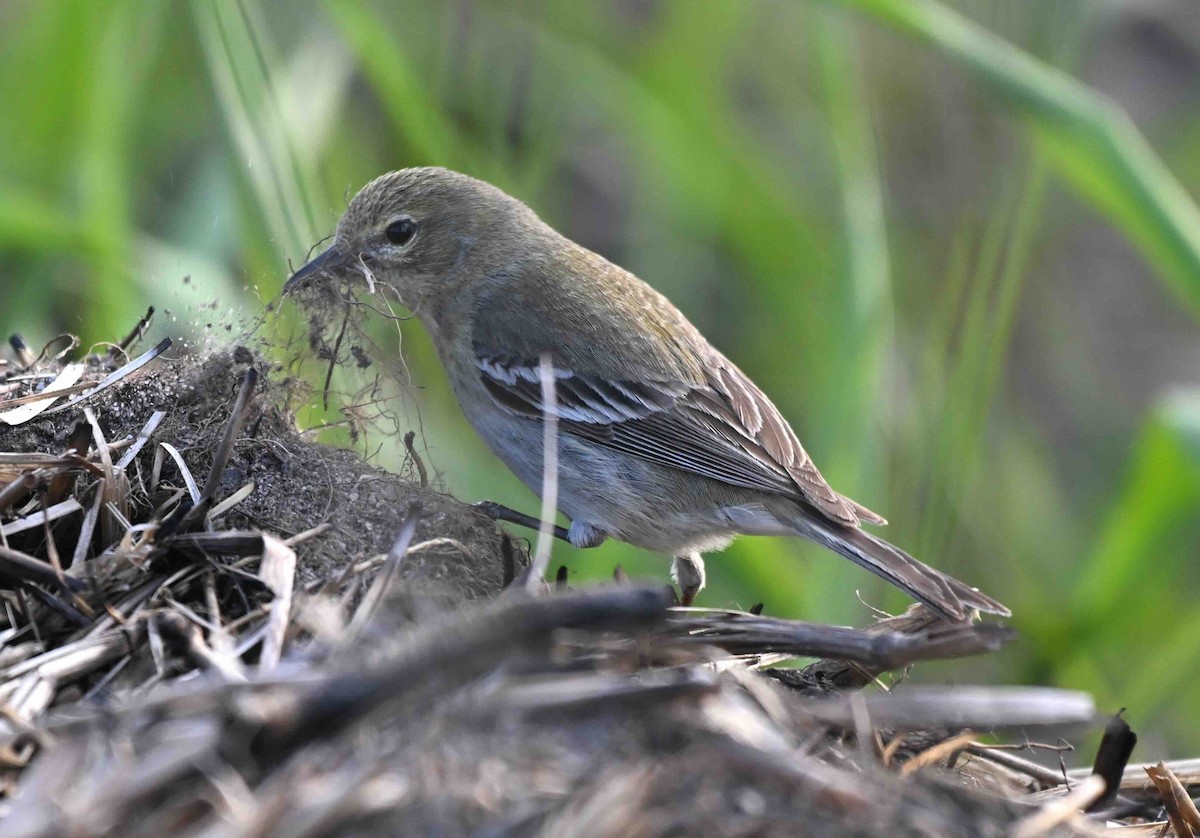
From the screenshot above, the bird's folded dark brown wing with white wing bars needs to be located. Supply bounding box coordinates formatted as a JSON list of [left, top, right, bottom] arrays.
[[475, 343, 884, 526]]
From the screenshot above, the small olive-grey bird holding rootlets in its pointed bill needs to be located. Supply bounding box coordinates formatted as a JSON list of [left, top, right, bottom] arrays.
[[283, 168, 1009, 619]]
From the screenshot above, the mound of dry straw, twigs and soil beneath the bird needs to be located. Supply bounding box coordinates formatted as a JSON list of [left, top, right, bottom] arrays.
[[0, 323, 1200, 838]]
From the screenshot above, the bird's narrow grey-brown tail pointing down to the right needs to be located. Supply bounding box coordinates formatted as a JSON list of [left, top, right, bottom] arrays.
[[794, 515, 1012, 621]]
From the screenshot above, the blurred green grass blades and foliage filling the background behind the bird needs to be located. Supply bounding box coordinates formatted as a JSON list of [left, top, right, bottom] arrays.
[[0, 0, 1200, 755]]
